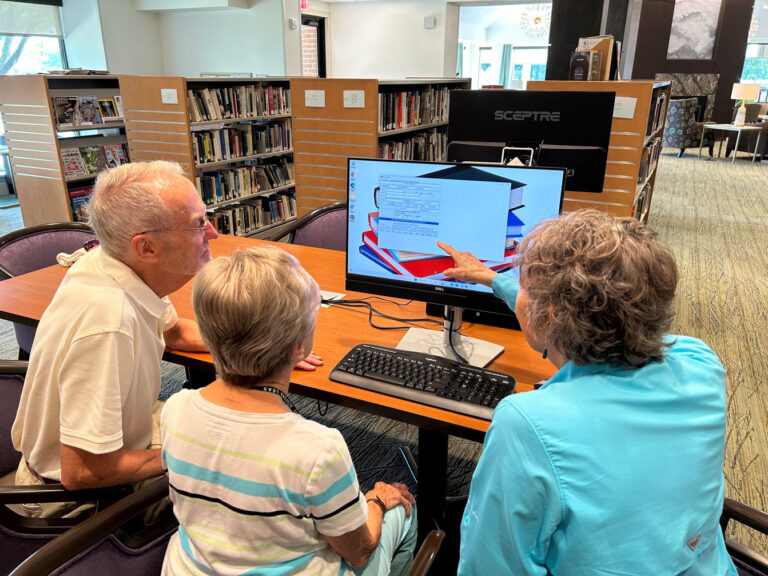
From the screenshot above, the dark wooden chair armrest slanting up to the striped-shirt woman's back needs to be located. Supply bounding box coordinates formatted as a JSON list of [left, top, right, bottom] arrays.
[[11, 476, 168, 576]]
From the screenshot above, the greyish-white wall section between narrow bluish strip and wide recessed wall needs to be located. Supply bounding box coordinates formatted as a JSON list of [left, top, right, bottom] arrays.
[[98, 0, 163, 75]]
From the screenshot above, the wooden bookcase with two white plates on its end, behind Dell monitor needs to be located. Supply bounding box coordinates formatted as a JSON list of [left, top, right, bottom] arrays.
[[291, 78, 470, 216]]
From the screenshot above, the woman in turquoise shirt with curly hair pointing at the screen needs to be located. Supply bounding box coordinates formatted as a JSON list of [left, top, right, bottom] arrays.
[[443, 211, 736, 576]]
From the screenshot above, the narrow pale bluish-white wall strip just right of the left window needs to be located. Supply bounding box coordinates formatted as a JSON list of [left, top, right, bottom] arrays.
[[61, 0, 107, 70]]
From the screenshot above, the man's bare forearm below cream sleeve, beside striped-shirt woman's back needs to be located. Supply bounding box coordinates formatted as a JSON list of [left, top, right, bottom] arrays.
[[59, 444, 164, 490]]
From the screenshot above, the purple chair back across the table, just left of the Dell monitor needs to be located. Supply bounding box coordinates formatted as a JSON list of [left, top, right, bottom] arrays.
[[265, 202, 347, 250]]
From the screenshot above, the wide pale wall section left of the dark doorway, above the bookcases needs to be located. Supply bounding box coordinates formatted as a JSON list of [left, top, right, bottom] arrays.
[[158, 0, 288, 76]]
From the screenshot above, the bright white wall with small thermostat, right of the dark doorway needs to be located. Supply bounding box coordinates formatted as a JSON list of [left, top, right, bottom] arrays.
[[328, 0, 448, 79]]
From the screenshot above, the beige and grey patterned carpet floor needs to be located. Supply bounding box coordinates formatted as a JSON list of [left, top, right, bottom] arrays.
[[0, 150, 768, 553]]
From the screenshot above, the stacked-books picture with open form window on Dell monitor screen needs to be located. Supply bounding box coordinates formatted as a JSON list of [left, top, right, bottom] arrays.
[[359, 165, 525, 280]]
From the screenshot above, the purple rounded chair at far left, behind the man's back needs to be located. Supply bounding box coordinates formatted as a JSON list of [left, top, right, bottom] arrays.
[[0, 222, 96, 360]]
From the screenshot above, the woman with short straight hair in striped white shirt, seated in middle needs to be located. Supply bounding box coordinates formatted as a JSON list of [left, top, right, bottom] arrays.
[[161, 246, 416, 576]]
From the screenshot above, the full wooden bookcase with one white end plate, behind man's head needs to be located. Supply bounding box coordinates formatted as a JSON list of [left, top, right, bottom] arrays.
[[120, 75, 296, 236]]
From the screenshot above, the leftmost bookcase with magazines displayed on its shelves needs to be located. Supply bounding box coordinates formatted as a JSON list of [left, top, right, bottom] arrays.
[[0, 74, 128, 226]]
